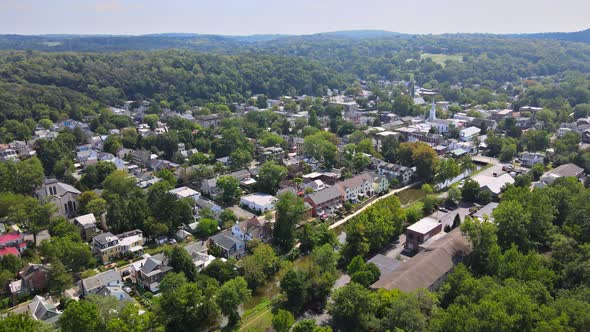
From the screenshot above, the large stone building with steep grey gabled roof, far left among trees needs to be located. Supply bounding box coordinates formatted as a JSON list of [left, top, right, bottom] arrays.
[[37, 179, 81, 218]]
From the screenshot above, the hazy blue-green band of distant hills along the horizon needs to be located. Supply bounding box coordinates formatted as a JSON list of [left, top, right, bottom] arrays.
[[0, 29, 590, 55]]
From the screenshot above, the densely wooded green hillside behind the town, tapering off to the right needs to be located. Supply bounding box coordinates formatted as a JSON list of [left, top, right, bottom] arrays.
[[0, 50, 347, 111]]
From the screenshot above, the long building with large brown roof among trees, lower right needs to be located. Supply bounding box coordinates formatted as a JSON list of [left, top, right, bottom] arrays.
[[371, 228, 473, 292]]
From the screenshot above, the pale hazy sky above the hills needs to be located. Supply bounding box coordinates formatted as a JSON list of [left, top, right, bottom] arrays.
[[0, 0, 590, 35]]
